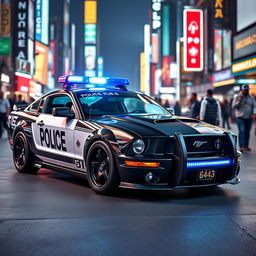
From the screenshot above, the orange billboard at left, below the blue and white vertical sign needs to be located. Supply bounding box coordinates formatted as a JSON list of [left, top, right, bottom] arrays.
[[34, 41, 48, 85]]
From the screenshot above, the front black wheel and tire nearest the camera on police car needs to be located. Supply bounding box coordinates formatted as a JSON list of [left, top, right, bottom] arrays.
[[86, 141, 120, 194]]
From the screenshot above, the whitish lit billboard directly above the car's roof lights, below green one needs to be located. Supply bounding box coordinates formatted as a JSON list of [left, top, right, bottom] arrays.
[[84, 45, 96, 76]]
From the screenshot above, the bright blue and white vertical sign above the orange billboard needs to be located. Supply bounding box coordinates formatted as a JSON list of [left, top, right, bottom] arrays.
[[35, 0, 49, 44]]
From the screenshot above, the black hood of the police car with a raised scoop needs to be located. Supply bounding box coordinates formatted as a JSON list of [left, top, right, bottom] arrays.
[[93, 114, 225, 137]]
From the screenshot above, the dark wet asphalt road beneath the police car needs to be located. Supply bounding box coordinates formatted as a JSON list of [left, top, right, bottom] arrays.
[[0, 126, 256, 256]]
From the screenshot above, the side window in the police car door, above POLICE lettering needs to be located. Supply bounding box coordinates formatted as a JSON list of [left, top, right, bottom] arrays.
[[43, 95, 73, 114]]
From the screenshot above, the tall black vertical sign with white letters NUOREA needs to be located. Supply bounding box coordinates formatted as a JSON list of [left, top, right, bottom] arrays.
[[12, 0, 28, 60]]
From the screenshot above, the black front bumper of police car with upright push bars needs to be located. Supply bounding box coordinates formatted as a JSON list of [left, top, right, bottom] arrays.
[[118, 133, 240, 190]]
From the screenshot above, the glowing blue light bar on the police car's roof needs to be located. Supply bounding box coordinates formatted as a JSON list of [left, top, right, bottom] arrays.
[[58, 75, 129, 86]]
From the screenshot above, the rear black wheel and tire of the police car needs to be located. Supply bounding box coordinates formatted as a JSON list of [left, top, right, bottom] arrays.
[[13, 132, 39, 174]]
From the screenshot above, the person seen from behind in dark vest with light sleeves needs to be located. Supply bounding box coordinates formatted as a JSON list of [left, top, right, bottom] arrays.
[[200, 89, 221, 125]]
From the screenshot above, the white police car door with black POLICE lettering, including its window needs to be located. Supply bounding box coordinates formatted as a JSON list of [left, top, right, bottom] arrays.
[[32, 94, 77, 168]]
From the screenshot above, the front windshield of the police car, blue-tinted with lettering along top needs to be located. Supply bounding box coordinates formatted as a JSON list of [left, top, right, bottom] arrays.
[[76, 91, 170, 116]]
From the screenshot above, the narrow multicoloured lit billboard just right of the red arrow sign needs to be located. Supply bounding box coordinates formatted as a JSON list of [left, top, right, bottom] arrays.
[[213, 29, 222, 71]]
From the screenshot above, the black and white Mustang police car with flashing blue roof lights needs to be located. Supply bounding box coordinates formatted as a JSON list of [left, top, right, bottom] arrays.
[[8, 76, 240, 194]]
